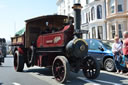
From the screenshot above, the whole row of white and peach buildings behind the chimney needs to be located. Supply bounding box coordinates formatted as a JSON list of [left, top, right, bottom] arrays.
[[57, 0, 128, 40]]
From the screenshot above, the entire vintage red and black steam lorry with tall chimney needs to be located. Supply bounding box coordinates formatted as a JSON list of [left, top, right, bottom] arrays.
[[12, 4, 100, 83]]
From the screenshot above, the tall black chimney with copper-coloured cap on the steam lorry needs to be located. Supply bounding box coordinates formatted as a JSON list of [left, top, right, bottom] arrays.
[[72, 2, 82, 38]]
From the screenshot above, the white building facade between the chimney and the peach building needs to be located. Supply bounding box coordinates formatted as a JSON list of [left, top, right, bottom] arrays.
[[81, 0, 107, 40]]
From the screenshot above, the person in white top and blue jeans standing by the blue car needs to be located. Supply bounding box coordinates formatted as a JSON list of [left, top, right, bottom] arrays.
[[112, 35, 123, 74]]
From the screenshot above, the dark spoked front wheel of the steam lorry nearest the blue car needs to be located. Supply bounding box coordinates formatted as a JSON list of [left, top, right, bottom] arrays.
[[83, 57, 100, 79]]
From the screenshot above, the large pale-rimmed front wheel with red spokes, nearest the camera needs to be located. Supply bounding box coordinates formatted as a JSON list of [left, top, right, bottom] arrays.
[[52, 56, 70, 83]]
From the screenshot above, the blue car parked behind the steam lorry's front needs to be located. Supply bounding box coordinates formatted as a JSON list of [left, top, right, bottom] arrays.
[[86, 39, 115, 72]]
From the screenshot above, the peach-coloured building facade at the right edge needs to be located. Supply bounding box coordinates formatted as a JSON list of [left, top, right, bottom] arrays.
[[106, 0, 128, 40]]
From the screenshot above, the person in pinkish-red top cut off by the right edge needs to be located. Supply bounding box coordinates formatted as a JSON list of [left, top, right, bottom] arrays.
[[123, 31, 128, 75]]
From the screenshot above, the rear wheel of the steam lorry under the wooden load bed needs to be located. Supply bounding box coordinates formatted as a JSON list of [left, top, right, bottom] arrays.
[[14, 51, 24, 72]]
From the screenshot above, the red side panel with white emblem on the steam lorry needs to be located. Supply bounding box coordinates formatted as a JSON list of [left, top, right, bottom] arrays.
[[37, 25, 70, 48]]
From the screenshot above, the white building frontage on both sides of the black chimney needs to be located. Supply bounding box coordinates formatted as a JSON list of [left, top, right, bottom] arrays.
[[57, 0, 106, 39]]
